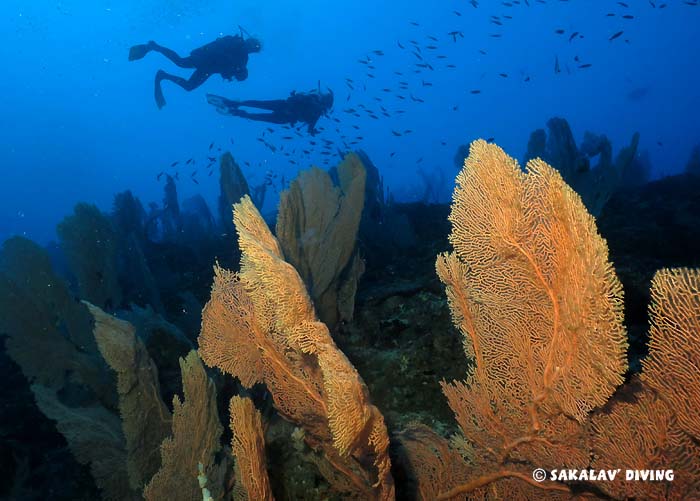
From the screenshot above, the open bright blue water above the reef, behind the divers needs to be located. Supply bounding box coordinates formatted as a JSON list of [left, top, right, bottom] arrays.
[[0, 0, 700, 243]]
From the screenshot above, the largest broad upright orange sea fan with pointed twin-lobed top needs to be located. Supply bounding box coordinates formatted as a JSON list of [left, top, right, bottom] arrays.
[[437, 137, 626, 497]]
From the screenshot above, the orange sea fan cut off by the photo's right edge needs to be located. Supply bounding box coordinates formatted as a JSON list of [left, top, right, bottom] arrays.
[[592, 268, 700, 499]]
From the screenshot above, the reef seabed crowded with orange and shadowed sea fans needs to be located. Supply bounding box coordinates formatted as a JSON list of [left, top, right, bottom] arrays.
[[0, 138, 700, 500]]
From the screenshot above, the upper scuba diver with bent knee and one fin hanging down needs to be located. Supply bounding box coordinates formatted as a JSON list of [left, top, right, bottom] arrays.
[[129, 27, 261, 109]]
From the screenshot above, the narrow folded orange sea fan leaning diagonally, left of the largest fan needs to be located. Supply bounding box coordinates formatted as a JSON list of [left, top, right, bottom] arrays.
[[199, 193, 394, 500]]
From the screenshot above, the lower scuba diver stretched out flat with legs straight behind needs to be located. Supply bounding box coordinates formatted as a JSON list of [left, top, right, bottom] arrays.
[[207, 89, 333, 136]]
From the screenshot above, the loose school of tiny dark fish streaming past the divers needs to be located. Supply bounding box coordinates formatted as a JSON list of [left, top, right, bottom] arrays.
[[157, 0, 700, 187]]
